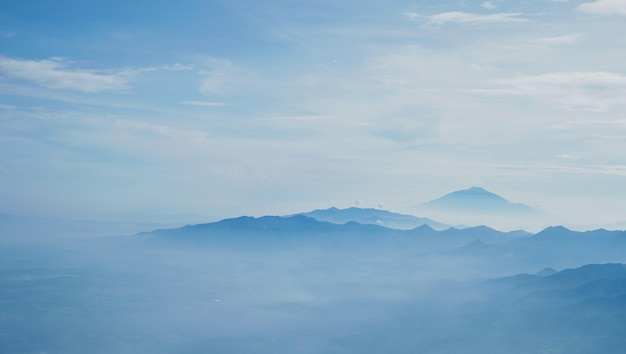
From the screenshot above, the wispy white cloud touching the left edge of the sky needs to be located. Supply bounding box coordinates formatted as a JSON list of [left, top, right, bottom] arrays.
[[0, 57, 128, 92]]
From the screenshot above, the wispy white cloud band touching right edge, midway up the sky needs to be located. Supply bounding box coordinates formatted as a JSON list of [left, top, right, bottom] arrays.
[[472, 72, 626, 111]]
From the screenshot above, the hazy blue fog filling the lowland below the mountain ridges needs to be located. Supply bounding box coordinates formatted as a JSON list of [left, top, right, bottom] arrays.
[[0, 220, 626, 353]]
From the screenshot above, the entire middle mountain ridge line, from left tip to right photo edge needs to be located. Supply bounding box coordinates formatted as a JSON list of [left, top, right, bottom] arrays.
[[139, 215, 626, 270]]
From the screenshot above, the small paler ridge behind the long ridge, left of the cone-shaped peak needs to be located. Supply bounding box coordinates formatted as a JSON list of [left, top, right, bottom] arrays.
[[299, 207, 450, 230]]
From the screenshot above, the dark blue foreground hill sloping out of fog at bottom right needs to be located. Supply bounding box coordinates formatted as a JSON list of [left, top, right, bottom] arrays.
[[354, 264, 626, 354]]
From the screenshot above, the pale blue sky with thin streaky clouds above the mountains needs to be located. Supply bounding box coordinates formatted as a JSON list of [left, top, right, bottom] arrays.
[[0, 0, 626, 223]]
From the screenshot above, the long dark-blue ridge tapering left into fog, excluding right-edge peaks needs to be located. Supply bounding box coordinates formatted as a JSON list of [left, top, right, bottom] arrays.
[[137, 215, 529, 254]]
